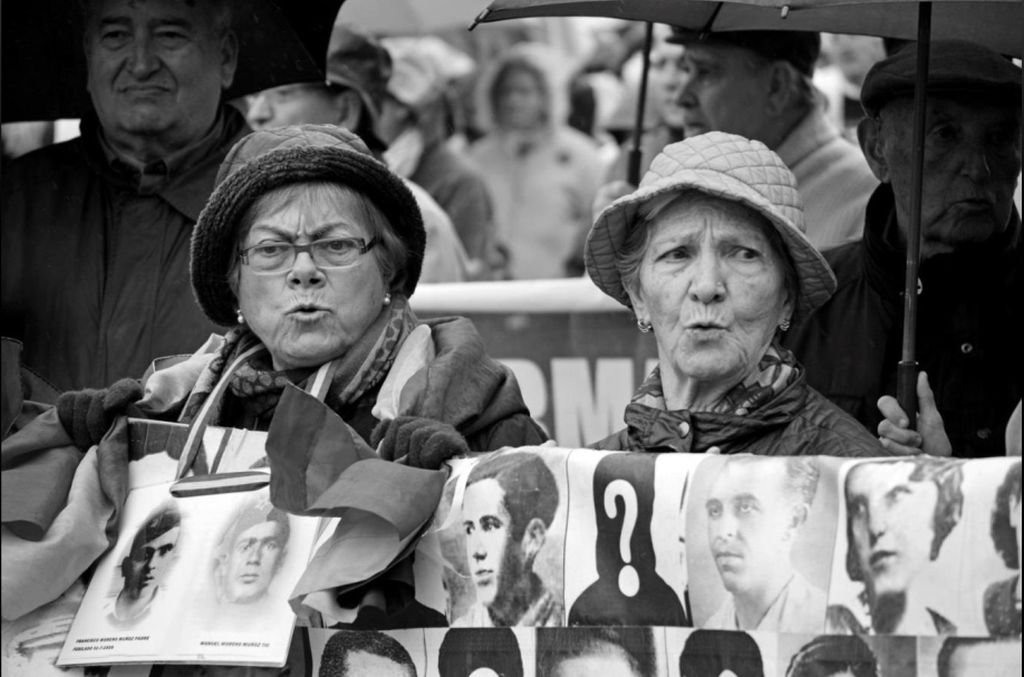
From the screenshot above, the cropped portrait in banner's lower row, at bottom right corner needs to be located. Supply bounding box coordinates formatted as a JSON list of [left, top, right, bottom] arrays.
[[918, 636, 1021, 677]]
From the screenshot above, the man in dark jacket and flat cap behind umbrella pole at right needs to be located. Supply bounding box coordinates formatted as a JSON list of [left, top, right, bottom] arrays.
[[786, 41, 1022, 457]]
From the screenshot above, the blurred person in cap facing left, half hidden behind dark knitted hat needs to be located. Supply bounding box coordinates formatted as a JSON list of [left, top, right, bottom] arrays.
[[248, 26, 469, 283]]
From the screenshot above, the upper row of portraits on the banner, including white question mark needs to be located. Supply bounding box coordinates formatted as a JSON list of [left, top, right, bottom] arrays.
[[438, 450, 1021, 636]]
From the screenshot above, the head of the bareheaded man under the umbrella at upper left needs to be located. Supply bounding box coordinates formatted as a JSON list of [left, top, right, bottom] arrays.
[[85, 0, 238, 144]]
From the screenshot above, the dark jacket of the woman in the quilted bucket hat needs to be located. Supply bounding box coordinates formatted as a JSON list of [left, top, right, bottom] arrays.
[[590, 366, 889, 457]]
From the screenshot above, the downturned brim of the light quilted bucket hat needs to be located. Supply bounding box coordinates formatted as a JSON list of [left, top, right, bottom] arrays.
[[584, 168, 836, 321]]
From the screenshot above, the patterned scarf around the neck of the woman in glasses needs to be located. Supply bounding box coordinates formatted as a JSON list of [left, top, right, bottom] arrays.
[[178, 295, 419, 425]]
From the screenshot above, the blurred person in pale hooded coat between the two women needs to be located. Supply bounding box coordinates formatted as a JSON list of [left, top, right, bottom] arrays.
[[468, 43, 603, 279]]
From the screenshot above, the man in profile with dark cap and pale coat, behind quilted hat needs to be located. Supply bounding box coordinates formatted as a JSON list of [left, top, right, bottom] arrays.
[[671, 29, 878, 249]]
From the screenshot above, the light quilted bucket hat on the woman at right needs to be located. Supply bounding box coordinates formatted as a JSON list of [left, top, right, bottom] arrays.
[[584, 132, 836, 319]]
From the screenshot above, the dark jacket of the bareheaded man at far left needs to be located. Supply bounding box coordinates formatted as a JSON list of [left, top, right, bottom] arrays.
[[0, 107, 249, 390]]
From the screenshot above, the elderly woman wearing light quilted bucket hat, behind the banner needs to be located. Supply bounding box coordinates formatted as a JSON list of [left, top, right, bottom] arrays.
[[584, 132, 887, 456]]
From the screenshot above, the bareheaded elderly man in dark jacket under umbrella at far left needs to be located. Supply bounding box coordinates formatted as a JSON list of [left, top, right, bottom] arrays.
[[2, 0, 248, 389]]
